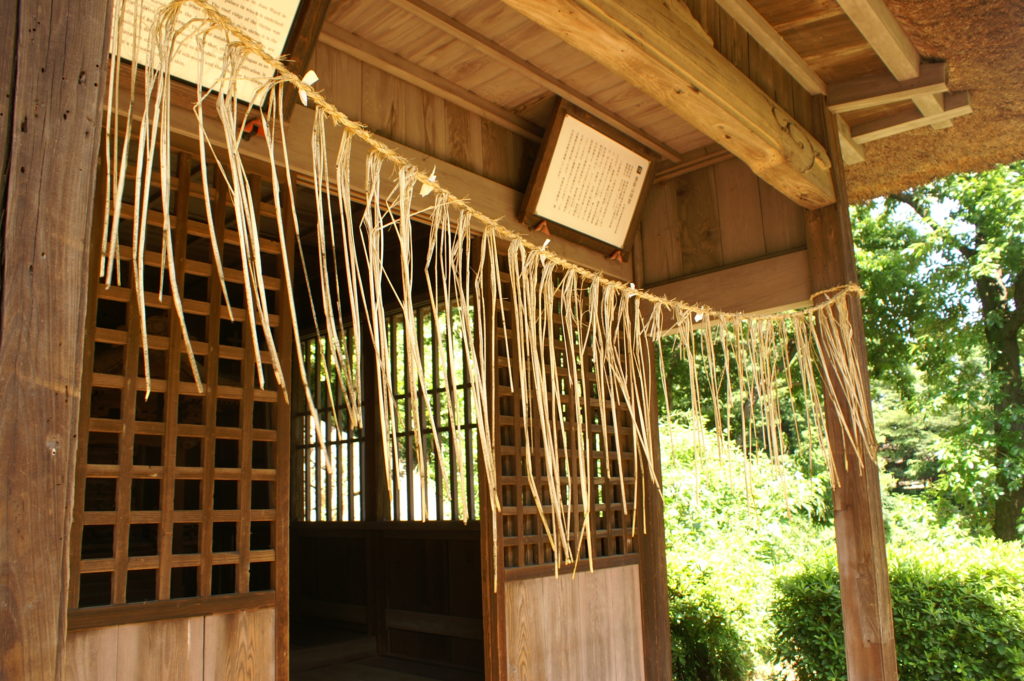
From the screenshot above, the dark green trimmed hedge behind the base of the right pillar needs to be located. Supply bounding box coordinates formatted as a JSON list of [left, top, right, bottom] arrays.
[[772, 542, 1024, 681]]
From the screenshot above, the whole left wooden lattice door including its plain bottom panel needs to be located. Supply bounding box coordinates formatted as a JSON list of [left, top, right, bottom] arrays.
[[69, 146, 292, 679]]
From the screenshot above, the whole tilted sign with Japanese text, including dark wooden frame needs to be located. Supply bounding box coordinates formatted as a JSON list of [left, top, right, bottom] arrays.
[[519, 100, 657, 253]]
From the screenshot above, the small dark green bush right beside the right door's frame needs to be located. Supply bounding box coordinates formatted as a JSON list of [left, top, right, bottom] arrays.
[[669, 572, 753, 681]]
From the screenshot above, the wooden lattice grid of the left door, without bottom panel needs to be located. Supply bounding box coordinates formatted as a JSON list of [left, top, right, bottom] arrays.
[[70, 148, 292, 608]]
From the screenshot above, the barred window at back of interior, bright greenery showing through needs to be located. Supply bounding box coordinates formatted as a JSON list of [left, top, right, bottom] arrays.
[[295, 305, 479, 522]]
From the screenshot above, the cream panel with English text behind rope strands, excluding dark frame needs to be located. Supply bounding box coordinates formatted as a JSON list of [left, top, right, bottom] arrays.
[[115, 0, 300, 104]]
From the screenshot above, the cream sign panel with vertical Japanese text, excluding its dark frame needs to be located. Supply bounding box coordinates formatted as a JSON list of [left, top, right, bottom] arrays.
[[535, 116, 650, 248]]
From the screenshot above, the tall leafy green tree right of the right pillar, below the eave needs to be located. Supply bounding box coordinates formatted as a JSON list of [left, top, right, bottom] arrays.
[[853, 162, 1024, 540]]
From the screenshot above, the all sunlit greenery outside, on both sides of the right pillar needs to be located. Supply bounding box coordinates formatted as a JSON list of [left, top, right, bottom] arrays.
[[662, 163, 1024, 681]]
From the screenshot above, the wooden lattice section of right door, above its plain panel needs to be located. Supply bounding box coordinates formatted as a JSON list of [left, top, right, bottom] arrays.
[[495, 266, 638, 579]]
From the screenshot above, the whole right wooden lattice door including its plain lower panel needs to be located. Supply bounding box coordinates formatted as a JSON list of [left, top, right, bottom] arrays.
[[481, 260, 645, 681]]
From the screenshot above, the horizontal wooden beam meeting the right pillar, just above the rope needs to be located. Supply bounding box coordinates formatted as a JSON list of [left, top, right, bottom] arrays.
[[650, 249, 811, 312]]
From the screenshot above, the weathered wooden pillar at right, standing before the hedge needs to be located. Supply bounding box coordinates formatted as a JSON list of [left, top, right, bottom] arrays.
[[807, 97, 897, 681]]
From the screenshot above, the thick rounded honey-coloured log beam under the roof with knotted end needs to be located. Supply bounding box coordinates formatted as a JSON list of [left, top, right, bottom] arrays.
[[495, 0, 836, 207]]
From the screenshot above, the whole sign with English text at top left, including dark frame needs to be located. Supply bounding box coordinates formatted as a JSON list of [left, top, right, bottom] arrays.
[[111, 0, 328, 105]]
